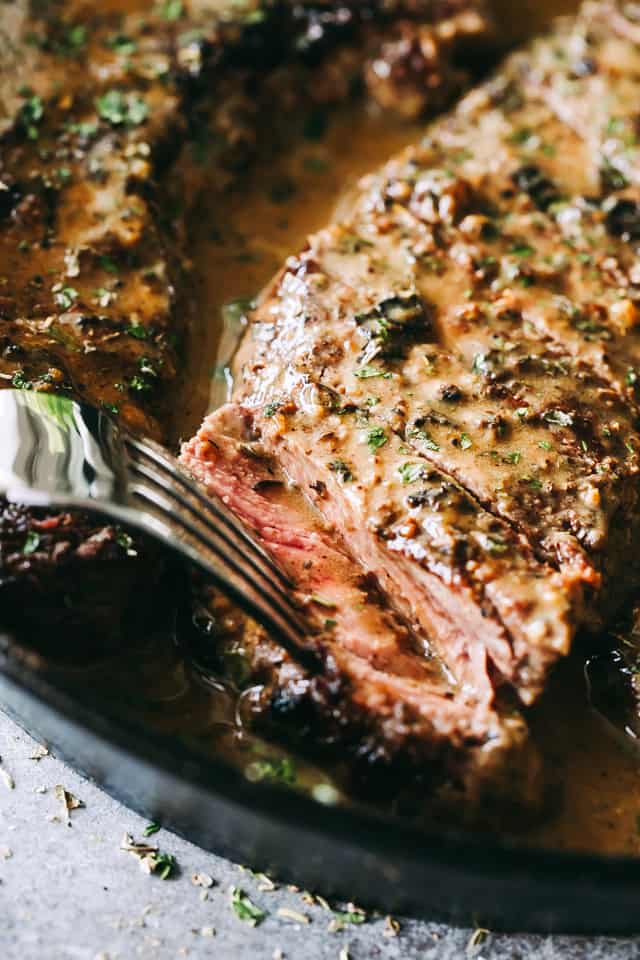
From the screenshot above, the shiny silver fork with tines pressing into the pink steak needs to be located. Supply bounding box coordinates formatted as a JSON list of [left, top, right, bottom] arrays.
[[0, 390, 315, 667]]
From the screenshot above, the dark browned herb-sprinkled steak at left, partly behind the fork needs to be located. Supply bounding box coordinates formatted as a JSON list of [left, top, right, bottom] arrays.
[[0, 0, 484, 649]]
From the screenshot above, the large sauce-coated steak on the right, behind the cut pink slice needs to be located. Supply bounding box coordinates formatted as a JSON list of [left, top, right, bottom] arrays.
[[178, 3, 640, 808]]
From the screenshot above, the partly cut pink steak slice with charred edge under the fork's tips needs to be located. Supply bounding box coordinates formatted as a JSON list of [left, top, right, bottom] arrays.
[[182, 406, 541, 812]]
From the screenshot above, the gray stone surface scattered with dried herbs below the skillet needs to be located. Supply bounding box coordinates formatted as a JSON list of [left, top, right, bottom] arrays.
[[0, 714, 640, 960]]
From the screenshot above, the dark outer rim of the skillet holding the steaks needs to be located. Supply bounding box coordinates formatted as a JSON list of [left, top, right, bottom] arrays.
[[0, 640, 640, 934]]
